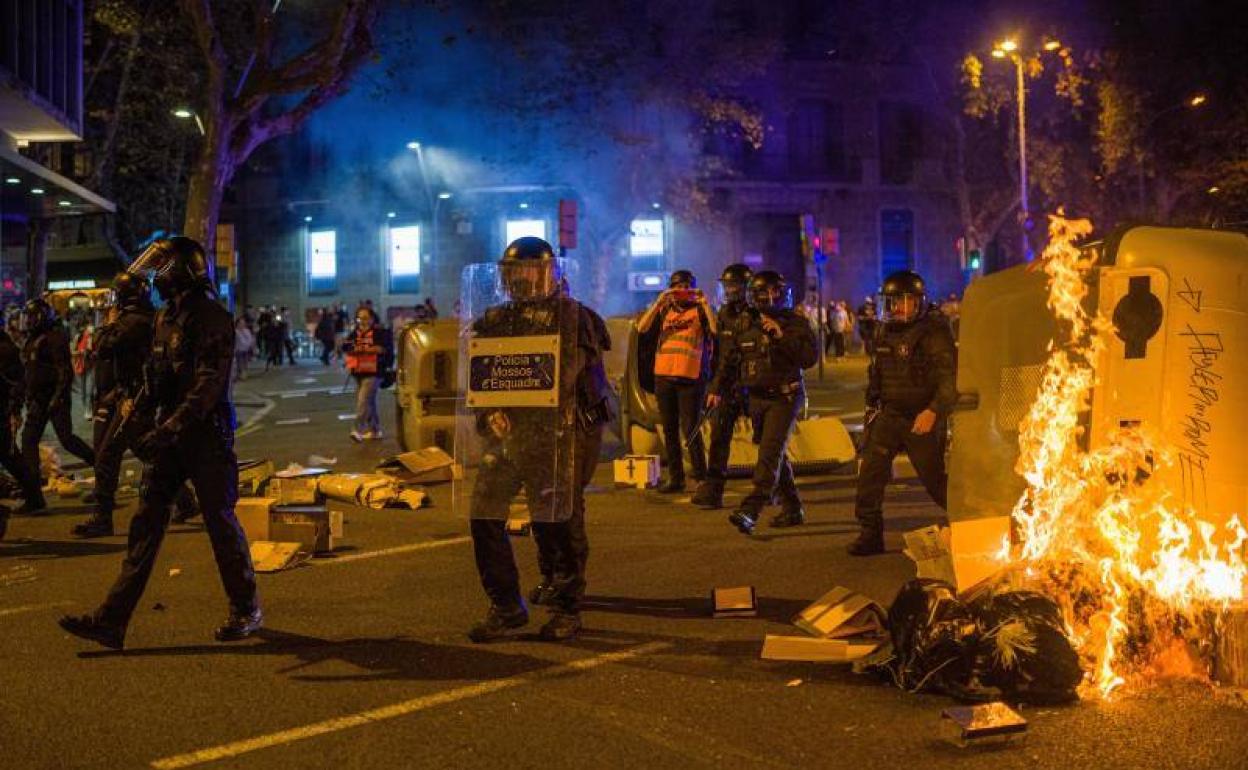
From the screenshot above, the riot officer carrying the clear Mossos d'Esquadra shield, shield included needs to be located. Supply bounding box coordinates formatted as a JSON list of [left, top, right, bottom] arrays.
[[457, 237, 610, 643]]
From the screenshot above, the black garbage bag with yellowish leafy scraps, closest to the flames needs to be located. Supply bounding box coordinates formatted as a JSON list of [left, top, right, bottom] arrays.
[[970, 590, 1083, 705]]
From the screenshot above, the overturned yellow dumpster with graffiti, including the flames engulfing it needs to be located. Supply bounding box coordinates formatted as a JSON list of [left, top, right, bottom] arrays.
[[948, 217, 1248, 695]]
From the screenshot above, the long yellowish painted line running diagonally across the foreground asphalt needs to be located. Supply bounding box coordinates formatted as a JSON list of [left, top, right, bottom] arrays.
[[151, 641, 671, 770]]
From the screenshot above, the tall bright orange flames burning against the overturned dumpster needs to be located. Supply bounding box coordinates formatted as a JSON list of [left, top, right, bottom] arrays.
[[1012, 209, 1248, 698]]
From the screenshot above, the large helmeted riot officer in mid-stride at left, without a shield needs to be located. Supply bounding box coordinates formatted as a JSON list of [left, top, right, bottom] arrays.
[[60, 237, 263, 649]]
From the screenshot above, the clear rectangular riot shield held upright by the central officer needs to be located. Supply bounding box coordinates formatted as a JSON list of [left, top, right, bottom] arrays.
[[454, 260, 580, 521]]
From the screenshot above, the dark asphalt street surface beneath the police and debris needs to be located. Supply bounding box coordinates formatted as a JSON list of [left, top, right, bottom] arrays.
[[0, 363, 1248, 769]]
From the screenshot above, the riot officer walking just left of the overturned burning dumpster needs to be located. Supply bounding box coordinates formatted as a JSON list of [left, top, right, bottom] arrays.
[[849, 270, 957, 557]]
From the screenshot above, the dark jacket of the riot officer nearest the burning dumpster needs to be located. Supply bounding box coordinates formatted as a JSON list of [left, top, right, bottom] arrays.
[[866, 312, 957, 417]]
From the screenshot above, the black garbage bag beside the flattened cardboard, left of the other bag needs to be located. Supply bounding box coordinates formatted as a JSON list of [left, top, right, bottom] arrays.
[[889, 578, 978, 694]]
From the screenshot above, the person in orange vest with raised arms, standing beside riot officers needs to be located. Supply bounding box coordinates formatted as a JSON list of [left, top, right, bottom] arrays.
[[636, 270, 715, 494]]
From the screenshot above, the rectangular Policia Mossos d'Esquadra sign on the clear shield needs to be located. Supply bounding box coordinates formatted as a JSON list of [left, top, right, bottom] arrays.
[[467, 334, 559, 407]]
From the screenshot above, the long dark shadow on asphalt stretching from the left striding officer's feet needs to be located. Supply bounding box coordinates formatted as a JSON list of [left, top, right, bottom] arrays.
[[71, 629, 559, 683]]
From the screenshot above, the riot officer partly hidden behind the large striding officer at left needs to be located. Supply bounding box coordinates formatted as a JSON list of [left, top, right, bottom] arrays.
[[74, 272, 195, 538]]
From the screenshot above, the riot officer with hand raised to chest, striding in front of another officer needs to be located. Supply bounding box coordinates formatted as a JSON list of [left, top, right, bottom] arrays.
[[711, 270, 819, 534]]
